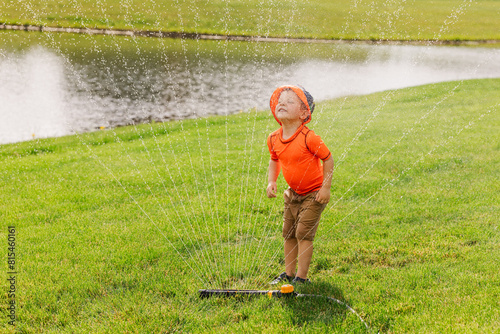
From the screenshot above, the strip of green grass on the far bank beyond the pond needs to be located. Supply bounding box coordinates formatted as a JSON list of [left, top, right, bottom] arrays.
[[0, 0, 500, 40]]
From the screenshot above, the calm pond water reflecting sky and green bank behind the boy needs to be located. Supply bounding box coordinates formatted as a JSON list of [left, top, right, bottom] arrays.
[[0, 31, 500, 143]]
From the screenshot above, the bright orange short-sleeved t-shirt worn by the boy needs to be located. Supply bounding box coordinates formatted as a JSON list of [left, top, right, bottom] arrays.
[[267, 125, 331, 195]]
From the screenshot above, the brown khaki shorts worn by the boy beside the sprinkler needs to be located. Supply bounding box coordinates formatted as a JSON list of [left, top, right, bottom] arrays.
[[283, 188, 326, 241]]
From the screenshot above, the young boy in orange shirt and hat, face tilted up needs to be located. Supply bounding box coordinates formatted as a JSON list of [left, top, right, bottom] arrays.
[[267, 86, 334, 284]]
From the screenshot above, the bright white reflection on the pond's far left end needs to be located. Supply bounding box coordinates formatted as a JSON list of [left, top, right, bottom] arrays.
[[0, 47, 70, 143]]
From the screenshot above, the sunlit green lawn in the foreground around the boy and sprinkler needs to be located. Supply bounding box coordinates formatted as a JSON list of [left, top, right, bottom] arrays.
[[0, 79, 500, 333]]
